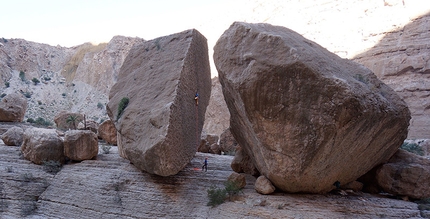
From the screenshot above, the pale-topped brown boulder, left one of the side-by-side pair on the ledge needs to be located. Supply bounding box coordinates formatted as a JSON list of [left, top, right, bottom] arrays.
[[21, 128, 65, 164]]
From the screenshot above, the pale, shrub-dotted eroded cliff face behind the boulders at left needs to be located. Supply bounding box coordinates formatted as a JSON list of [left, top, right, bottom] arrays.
[[0, 36, 143, 125]]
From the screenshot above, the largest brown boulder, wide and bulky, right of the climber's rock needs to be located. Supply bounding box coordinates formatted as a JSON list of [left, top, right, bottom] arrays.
[[214, 22, 410, 193]]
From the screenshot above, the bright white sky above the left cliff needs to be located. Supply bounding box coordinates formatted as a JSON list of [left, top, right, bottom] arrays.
[[0, 0, 233, 47]]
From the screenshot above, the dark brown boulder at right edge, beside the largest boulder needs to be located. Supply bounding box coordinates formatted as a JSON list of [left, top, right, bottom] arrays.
[[376, 149, 430, 199]]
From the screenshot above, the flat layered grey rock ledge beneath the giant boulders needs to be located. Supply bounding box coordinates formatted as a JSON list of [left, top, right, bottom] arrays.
[[0, 144, 429, 218]]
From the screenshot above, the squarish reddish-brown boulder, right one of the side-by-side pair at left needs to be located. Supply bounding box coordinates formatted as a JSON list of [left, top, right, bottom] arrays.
[[64, 130, 99, 161]]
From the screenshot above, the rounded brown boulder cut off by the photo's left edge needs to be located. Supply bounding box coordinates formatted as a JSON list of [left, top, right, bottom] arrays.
[[0, 93, 27, 122]]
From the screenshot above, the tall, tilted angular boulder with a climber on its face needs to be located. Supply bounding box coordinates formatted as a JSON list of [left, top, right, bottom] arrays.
[[106, 30, 211, 176]]
